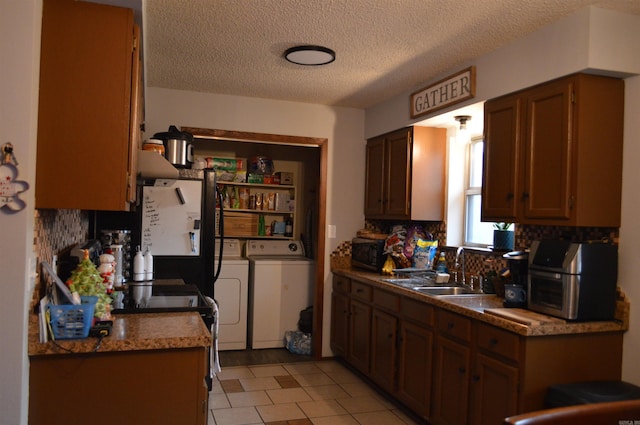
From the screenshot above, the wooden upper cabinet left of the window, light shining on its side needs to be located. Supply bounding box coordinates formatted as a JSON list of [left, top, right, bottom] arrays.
[[364, 127, 446, 221]]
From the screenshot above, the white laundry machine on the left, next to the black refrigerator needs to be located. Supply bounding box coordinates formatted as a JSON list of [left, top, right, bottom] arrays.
[[213, 239, 249, 351]]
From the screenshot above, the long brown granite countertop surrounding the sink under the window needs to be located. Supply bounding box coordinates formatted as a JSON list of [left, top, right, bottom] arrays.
[[332, 268, 629, 336]]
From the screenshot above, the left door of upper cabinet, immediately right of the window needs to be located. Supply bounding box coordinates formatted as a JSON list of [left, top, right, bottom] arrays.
[[482, 96, 522, 221]]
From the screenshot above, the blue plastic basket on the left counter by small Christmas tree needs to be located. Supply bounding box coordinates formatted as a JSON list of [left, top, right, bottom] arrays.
[[48, 296, 98, 339]]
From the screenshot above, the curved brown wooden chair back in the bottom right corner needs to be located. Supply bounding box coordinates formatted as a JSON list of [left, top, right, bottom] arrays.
[[504, 400, 640, 425]]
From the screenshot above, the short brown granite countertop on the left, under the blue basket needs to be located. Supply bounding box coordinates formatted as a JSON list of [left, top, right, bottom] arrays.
[[29, 312, 211, 356]]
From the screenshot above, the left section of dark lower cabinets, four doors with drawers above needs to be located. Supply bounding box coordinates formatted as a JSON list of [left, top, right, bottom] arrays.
[[330, 276, 434, 419]]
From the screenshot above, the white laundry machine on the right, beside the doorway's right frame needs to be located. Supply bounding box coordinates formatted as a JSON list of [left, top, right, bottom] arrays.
[[245, 240, 315, 349]]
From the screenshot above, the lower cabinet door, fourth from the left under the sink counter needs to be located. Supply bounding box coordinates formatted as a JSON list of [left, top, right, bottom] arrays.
[[397, 321, 433, 419]]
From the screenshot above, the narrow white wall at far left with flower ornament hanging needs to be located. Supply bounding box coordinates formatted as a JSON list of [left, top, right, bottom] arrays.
[[0, 0, 42, 425]]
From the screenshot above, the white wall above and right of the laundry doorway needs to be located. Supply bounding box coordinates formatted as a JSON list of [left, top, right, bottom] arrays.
[[145, 87, 366, 356]]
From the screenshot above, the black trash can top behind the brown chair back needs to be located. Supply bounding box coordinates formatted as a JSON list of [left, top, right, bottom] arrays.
[[544, 381, 640, 408]]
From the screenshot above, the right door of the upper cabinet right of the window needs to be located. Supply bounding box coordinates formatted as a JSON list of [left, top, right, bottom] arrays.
[[523, 80, 577, 220]]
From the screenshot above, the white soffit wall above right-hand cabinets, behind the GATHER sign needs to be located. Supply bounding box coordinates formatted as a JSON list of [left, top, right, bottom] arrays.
[[365, 7, 640, 138]]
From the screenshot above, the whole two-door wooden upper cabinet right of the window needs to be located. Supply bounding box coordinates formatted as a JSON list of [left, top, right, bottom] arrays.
[[482, 74, 624, 227]]
